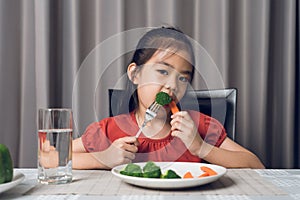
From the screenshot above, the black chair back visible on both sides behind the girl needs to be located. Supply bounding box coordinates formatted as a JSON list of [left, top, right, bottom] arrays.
[[109, 88, 237, 140]]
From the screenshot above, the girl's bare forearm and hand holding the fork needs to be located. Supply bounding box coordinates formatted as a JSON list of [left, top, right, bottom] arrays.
[[72, 137, 138, 169]]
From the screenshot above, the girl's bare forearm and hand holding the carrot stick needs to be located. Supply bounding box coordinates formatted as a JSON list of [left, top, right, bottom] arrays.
[[171, 111, 264, 168]]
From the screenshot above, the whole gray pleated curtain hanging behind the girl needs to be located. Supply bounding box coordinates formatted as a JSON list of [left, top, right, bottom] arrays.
[[0, 0, 300, 168]]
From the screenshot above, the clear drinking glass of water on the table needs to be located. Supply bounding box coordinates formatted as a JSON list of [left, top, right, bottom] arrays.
[[38, 108, 73, 184]]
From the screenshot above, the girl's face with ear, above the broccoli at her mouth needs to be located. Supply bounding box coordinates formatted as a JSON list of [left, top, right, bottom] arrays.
[[128, 51, 193, 111]]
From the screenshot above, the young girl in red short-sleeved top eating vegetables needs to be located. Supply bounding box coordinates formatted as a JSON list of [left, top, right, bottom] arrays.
[[73, 27, 264, 169]]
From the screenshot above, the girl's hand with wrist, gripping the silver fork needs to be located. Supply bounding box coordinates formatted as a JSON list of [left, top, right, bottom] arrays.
[[94, 137, 139, 168]]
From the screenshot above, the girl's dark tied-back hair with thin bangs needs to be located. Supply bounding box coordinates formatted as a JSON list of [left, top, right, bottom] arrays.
[[120, 27, 195, 115]]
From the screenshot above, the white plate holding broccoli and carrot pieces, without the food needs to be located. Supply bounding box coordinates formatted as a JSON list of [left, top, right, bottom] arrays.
[[111, 162, 226, 189]]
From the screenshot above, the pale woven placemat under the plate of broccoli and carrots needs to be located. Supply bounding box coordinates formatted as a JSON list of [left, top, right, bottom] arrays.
[[26, 169, 286, 196]]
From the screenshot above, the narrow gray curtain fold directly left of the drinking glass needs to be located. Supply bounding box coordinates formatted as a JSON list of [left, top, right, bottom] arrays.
[[18, 0, 37, 166]]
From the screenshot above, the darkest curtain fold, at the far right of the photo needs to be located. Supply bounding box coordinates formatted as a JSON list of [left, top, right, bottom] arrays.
[[265, 0, 299, 167]]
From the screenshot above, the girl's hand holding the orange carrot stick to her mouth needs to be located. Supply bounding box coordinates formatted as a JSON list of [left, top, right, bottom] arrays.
[[170, 111, 203, 156]]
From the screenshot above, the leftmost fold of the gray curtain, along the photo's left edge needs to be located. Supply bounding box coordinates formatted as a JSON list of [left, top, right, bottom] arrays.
[[0, 1, 22, 167]]
